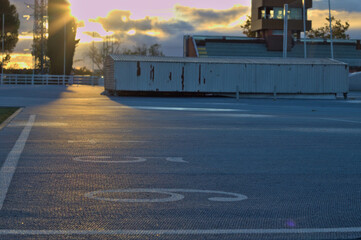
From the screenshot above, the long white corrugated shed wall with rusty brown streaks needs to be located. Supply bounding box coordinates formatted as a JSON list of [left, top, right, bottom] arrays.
[[105, 58, 349, 94]]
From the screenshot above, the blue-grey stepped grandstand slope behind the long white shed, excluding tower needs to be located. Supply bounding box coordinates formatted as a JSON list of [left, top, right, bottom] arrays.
[[191, 35, 361, 66]]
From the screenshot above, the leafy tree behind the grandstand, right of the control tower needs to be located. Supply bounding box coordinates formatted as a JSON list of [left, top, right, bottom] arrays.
[[307, 17, 350, 39]]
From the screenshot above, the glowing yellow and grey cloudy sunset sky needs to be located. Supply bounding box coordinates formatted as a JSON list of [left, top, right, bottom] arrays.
[[6, 0, 361, 68]]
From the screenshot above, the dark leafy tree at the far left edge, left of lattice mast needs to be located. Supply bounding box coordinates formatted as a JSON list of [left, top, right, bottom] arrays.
[[0, 0, 20, 63]]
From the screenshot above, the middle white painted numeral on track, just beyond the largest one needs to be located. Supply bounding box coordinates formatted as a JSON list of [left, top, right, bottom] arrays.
[[73, 156, 188, 163]]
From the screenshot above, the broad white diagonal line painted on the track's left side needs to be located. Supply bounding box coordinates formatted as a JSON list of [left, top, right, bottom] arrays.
[[0, 115, 36, 210]]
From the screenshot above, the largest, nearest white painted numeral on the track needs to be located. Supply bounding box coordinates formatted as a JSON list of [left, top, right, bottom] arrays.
[[85, 188, 248, 203]]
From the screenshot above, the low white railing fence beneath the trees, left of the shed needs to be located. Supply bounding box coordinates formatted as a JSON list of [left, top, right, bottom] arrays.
[[0, 74, 103, 86]]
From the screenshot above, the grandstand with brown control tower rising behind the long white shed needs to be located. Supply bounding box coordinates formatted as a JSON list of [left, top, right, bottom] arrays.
[[183, 0, 361, 70]]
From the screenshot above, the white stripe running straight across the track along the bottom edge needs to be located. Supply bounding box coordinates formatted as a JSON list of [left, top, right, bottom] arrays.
[[0, 227, 361, 236]]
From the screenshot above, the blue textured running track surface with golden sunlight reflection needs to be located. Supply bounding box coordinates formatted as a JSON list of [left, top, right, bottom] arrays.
[[0, 87, 361, 240]]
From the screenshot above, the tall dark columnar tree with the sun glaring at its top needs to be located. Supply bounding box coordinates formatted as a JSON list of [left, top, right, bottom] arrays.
[[48, 0, 79, 75]]
